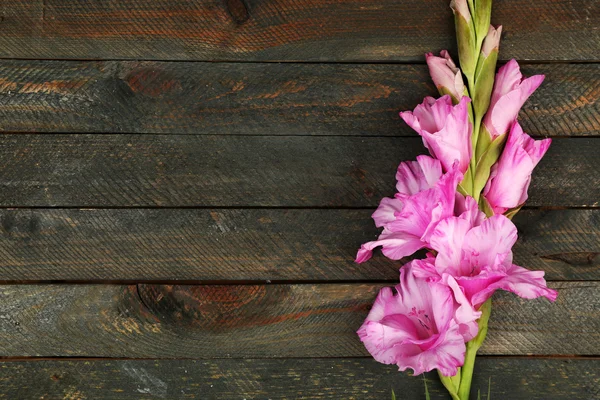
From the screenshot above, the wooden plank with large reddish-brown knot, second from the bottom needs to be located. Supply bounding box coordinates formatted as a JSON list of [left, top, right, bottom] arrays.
[[0, 282, 600, 358]]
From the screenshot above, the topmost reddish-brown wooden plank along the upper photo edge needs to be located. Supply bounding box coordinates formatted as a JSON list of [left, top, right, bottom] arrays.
[[0, 0, 600, 61]]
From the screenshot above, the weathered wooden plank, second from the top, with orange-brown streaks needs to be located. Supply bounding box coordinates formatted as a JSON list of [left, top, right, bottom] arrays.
[[0, 60, 600, 136]]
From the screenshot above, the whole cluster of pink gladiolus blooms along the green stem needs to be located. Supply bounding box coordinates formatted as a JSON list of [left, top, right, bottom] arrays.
[[356, 58, 557, 376]]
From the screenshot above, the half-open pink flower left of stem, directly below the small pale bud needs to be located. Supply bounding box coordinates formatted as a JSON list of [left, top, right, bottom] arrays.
[[400, 95, 473, 173]]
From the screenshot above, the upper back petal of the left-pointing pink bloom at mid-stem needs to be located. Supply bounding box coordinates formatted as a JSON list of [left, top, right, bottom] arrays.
[[396, 156, 442, 197]]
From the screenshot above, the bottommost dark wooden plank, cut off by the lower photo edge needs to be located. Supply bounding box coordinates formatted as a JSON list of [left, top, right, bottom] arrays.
[[0, 357, 600, 400]]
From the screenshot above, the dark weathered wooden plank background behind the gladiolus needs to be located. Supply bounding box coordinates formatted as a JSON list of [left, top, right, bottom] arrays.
[[0, 0, 600, 400]]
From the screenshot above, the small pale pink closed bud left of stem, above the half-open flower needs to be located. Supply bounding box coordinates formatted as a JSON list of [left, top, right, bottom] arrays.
[[425, 50, 465, 103]]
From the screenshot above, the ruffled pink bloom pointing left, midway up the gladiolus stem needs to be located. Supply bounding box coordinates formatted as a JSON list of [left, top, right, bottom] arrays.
[[356, 167, 463, 263]]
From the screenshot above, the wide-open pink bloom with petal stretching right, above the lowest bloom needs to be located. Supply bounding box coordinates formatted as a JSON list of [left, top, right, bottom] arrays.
[[412, 215, 557, 308]]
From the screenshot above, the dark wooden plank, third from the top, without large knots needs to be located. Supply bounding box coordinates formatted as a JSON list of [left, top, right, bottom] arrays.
[[0, 134, 600, 207]]
